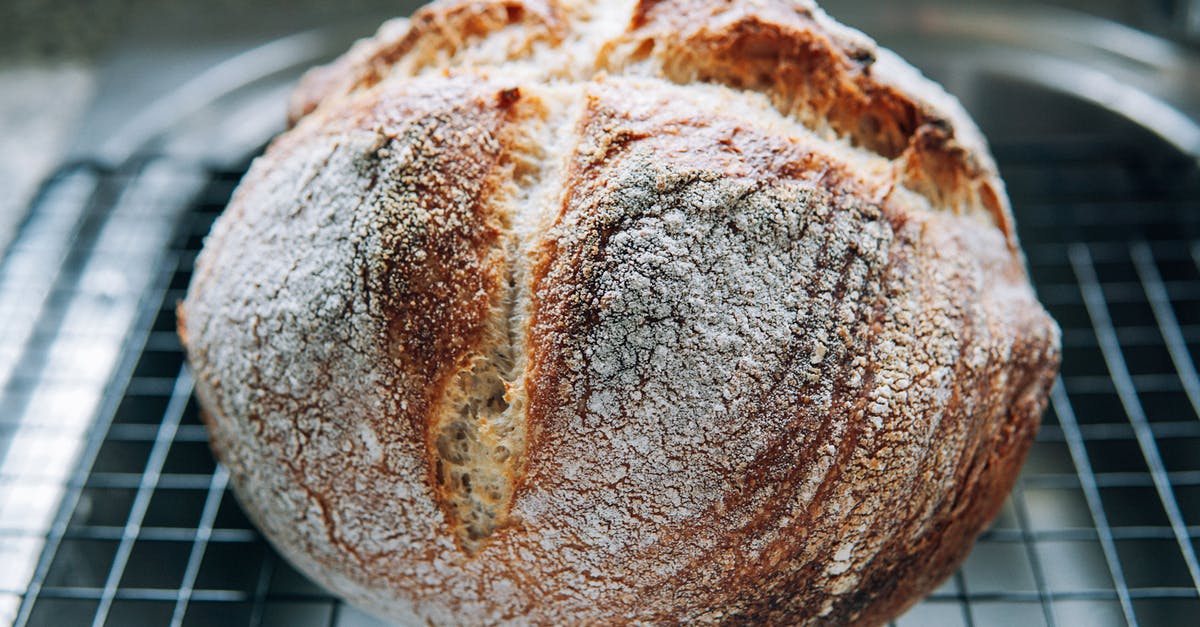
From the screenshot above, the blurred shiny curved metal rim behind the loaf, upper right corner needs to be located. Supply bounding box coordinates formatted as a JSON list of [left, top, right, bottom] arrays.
[[838, 1, 1200, 155]]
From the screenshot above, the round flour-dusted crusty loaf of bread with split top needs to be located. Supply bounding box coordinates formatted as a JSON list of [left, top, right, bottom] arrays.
[[179, 0, 1058, 625]]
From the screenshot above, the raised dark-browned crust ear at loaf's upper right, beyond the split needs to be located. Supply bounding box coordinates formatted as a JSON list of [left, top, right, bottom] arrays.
[[607, 0, 1015, 235]]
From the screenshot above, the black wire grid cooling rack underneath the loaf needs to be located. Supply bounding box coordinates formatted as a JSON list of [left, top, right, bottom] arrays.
[[0, 129, 1200, 627]]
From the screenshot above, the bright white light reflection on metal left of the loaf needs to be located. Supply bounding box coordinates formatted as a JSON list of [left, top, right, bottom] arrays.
[[0, 161, 204, 625]]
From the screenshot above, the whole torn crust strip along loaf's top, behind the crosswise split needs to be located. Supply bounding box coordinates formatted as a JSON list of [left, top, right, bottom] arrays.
[[289, 0, 1016, 239]]
